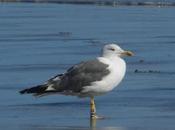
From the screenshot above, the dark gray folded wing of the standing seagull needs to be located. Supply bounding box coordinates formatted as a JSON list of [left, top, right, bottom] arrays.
[[48, 59, 109, 93]]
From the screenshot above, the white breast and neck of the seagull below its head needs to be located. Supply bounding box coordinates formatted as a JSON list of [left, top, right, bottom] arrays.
[[83, 57, 126, 95]]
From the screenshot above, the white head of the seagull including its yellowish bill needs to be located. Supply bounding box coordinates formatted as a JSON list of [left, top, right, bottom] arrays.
[[102, 44, 134, 57]]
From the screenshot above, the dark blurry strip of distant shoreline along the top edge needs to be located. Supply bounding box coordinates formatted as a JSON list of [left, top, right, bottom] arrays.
[[0, 0, 175, 7]]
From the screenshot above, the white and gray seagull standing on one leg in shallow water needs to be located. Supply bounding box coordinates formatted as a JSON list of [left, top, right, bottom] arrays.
[[20, 44, 133, 119]]
